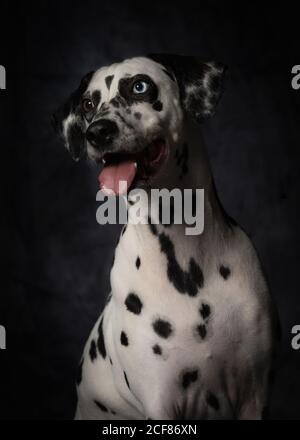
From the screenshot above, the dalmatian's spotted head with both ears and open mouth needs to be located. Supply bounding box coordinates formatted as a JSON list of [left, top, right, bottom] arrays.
[[53, 55, 224, 193]]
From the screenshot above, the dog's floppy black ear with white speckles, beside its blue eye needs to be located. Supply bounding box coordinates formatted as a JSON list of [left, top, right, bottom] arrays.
[[148, 54, 226, 121]]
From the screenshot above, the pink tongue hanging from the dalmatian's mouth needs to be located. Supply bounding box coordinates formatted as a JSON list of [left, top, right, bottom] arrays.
[[98, 161, 136, 194]]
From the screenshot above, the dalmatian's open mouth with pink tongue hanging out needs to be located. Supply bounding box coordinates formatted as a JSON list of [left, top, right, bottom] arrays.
[[98, 139, 167, 194]]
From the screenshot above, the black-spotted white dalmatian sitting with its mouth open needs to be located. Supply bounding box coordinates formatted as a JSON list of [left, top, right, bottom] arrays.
[[54, 54, 276, 420]]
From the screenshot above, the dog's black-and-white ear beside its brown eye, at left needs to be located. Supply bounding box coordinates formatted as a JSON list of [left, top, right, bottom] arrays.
[[51, 72, 94, 161]]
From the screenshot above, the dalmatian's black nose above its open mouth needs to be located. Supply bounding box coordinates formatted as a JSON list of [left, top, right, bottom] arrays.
[[86, 119, 118, 148]]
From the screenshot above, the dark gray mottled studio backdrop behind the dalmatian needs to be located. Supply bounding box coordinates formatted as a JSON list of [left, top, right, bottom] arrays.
[[0, 0, 300, 418]]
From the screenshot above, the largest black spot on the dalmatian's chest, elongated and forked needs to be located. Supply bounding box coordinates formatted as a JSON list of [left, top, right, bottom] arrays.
[[159, 233, 204, 296]]
